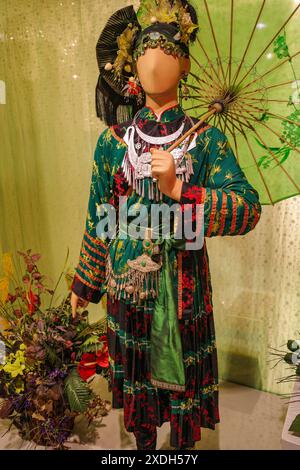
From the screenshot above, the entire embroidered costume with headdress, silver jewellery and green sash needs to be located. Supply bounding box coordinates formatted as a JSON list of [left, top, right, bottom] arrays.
[[72, 0, 261, 448]]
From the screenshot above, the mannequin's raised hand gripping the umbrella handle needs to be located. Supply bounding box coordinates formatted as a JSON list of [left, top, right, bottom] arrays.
[[150, 148, 182, 201]]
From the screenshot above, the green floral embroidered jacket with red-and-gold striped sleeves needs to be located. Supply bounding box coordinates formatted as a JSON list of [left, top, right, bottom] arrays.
[[72, 104, 261, 319]]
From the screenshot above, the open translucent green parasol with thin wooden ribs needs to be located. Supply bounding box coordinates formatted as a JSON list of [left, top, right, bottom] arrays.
[[169, 0, 300, 205]]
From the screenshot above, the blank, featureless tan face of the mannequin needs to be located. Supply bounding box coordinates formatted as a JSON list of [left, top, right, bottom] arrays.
[[136, 47, 191, 96]]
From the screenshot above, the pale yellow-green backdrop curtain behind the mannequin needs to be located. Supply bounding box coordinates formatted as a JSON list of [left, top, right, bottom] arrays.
[[0, 0, 300, 393]]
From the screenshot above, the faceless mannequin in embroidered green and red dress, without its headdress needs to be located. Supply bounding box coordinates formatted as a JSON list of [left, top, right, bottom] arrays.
[[71, 2, 261, 449]]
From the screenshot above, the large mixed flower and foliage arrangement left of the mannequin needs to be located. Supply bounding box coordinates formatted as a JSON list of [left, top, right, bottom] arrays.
[[0, 250, 111, 448]]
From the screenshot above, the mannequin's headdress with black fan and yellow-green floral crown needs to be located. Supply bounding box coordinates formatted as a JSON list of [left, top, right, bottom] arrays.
[[96, 0, 198, 126]]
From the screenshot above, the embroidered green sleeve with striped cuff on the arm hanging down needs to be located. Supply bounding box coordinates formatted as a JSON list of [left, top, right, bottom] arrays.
[[71, 129, 110, 303]]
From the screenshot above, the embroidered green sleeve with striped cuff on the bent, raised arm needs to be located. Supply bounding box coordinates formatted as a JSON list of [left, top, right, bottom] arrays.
[[180, 128, 261, 237]]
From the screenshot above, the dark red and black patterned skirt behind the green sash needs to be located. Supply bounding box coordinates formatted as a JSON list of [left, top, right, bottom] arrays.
[[107, 296, 220, 448]]
